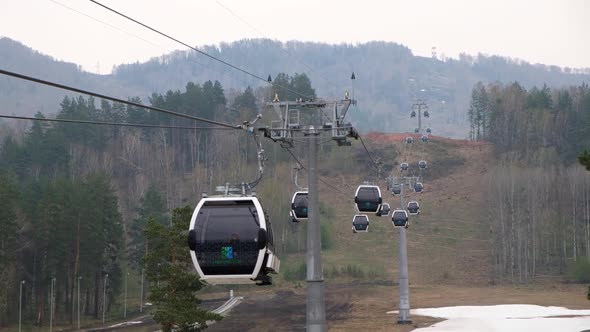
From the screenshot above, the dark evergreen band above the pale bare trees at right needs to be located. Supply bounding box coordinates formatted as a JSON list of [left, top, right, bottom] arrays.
[[468, 82, 590, 163]]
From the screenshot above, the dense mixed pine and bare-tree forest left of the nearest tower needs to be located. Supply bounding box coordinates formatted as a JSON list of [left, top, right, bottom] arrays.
[[0, 70, 328, 326]]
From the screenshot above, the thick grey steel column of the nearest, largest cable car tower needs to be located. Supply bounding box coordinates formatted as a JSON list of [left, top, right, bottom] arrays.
[[306, 126, 327, 332]]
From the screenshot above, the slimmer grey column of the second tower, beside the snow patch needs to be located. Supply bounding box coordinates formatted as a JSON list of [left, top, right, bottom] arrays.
[[397, 183, 412, 324]]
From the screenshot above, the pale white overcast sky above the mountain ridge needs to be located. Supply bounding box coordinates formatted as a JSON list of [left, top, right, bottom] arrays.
[[0, 0, 590, 73]]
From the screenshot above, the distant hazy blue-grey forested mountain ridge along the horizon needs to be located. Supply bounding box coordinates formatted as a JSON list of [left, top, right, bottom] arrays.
[[0, 38, 590, 138]]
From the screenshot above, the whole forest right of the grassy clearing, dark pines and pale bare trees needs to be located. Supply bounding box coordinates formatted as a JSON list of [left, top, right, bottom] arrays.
[[468, 82, 590, 282]]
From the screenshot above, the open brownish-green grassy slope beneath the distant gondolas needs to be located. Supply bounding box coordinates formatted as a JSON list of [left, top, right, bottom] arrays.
[[310, 134, 490, 284]]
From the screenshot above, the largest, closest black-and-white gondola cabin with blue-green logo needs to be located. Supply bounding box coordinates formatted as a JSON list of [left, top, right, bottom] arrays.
[[188, 196, 280, 285]]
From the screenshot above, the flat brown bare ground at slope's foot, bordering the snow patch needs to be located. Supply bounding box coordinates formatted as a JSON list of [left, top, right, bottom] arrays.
[[207, 283, 589, 332]]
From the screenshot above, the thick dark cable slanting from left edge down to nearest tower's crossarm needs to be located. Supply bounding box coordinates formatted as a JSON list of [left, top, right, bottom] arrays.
[[0, 69, 242, 129]]
